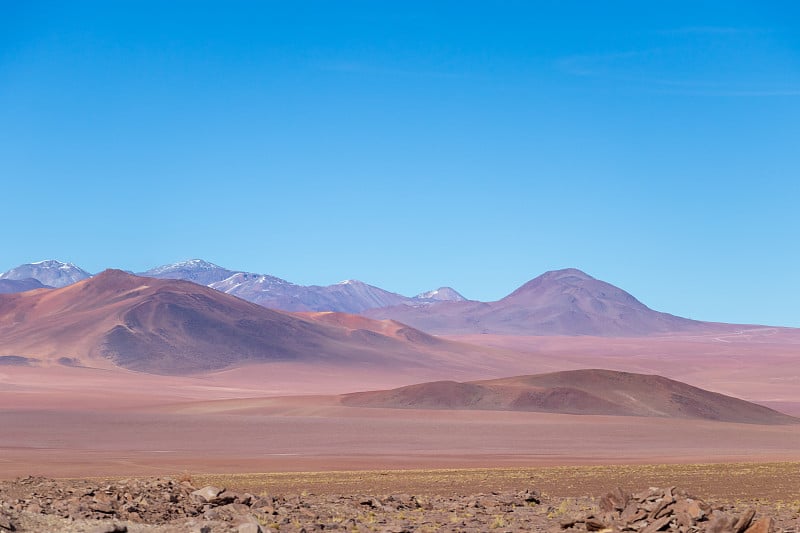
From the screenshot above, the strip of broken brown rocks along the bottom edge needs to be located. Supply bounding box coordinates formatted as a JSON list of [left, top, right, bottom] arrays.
[[0, 477, 800, 533]]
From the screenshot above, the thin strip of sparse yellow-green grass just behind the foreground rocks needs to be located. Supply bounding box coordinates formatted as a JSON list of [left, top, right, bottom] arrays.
[[184, 462, 800, 504]]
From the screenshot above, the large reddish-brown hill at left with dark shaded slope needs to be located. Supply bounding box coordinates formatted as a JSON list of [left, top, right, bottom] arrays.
[[0, 270, 478, 374]]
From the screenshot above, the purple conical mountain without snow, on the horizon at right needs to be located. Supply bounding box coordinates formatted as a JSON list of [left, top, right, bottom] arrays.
[[363, 268, 731, 337]]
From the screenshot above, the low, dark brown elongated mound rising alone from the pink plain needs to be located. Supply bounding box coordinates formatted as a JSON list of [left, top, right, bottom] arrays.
[[341, 370, 800, 424]]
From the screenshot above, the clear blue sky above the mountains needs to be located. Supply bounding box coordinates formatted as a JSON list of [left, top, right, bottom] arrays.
[[0, 0, 800, 326]]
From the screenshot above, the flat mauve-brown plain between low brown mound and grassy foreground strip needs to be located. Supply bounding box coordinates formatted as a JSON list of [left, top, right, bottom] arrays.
[[0, 388, 800, 477]]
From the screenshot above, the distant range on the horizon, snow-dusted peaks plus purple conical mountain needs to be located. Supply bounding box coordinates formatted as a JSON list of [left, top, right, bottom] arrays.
[[0, 259, 752, 337]]
